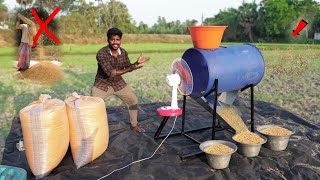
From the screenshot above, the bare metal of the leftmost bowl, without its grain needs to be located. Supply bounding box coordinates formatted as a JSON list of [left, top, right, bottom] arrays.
[[199, 140, 237, 169]]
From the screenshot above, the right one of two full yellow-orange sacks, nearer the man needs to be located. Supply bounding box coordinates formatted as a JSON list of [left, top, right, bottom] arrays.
[[65, 93, 109, 168]]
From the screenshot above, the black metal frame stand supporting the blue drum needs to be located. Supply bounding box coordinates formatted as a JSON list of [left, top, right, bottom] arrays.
[[154, 79, 254, 160]]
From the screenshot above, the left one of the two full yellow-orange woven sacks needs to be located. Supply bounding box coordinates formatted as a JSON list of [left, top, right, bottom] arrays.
[[19, 95, 69, 178]]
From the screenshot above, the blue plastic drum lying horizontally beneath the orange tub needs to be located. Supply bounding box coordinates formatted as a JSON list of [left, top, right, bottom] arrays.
[[182, 44, 265, 98]]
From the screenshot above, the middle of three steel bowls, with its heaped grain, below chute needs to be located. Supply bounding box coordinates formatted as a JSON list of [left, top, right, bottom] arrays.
[[232, 131, 267, 157]]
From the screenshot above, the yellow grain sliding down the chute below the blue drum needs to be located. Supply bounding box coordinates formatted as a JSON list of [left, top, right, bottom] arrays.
[[217, 105, 248, 133]]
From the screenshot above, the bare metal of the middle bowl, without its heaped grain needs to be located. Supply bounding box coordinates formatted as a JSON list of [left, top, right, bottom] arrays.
[[232, 134, 267, 157]]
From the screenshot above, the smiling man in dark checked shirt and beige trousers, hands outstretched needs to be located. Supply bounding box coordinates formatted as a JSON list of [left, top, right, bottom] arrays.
[[92, 28, 145, 132]]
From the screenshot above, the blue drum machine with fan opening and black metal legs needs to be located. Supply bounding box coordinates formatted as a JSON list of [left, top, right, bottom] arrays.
[[155, 26, 265, 158]]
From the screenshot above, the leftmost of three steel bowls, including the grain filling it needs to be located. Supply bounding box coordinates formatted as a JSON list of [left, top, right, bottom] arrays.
[[199, 140, 237, 169]]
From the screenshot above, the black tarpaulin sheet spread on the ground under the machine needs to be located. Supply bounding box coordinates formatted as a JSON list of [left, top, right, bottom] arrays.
[[2, 98, 320, 180]]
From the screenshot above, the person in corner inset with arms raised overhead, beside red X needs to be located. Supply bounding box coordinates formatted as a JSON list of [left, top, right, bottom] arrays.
[[16, 14, 36, 71]]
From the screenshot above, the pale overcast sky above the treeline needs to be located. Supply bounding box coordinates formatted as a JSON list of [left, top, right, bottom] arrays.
[[5, 0, 320, 26]]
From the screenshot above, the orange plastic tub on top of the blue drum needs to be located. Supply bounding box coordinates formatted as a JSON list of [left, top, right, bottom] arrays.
[[188, 26, 228, 49]]
